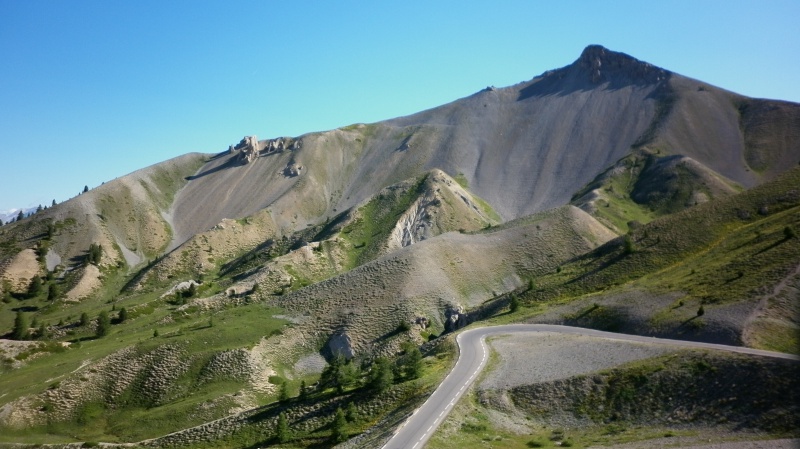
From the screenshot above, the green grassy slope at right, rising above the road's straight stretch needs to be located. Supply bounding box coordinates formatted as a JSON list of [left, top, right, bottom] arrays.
[[526, 169, 800, 353]]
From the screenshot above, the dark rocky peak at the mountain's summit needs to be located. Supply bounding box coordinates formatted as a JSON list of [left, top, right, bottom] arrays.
[[573, 45, 670, 84]]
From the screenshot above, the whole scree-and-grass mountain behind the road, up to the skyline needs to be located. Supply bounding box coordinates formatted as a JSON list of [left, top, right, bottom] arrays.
[[0, 46, 800, 447]]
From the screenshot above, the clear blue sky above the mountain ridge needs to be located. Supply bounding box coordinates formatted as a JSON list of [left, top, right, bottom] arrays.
[[0, 0, 800, 210]]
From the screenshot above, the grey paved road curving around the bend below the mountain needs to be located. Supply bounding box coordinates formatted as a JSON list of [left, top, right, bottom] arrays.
[[383, 324, 800, 449]]
